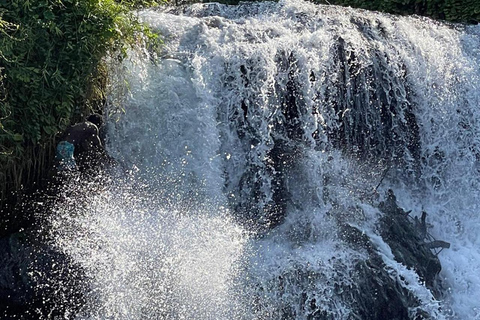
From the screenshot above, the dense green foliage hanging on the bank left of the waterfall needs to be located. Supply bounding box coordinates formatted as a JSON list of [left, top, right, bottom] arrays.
[[0, 0, 161, 198]]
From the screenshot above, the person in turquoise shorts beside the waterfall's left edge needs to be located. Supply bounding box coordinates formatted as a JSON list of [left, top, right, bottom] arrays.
[[55, 114, 104, 172]]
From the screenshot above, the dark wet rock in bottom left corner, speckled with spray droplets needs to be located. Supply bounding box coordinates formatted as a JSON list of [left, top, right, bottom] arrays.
[[0, 231, 88, 320]]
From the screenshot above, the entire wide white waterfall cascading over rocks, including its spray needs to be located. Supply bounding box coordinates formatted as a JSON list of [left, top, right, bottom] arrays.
[[39, 1, 480, 319]]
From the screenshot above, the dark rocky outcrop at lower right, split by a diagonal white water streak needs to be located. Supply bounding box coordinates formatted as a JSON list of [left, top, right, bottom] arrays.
[[326, 190, 441, 320]]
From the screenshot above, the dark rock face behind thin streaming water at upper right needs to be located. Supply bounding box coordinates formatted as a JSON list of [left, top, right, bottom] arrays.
[[323, 35, 420, 174]]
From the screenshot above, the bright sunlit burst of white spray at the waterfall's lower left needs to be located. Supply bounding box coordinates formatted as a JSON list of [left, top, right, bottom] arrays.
[[49, 177, 247, 319]]
